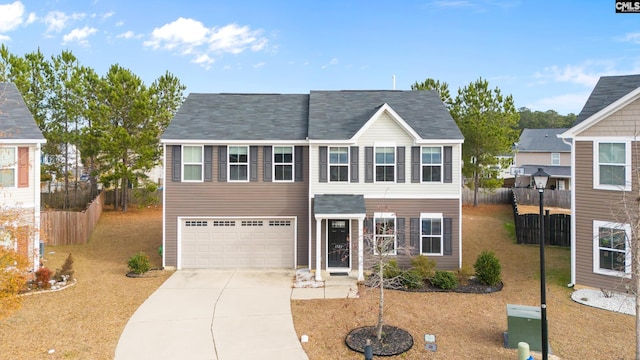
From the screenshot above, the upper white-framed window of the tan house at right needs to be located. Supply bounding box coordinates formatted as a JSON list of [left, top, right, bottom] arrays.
[[593, 141, 631, 191]]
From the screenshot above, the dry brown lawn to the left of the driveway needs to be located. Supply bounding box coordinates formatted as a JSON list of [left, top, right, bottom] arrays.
[[0, 208, 169, 359]]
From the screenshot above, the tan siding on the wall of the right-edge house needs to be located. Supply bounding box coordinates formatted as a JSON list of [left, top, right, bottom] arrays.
[[573, 141, 637, 289]]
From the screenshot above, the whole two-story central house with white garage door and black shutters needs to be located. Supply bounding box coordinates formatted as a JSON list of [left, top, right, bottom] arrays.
[[161, 91, 463, 279]]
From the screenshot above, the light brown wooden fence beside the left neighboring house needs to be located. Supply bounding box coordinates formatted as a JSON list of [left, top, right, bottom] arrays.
[[40, 192, 104, 246]]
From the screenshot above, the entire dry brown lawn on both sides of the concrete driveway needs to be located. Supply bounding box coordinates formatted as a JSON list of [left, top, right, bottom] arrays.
[[0, 205, 635, 360]]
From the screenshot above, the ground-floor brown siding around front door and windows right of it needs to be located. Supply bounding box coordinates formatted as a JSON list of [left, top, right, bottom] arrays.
[[311, 199, 460, 270]]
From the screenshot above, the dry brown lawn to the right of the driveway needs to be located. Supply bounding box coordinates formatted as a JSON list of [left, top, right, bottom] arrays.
[[291, 205, 635, 360]]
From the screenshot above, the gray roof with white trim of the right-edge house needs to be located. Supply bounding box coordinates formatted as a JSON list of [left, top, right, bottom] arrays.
[[558, 75, 640, 138]]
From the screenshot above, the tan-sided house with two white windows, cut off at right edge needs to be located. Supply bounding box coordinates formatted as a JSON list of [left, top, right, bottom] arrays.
[[559, 75, 640, 291]]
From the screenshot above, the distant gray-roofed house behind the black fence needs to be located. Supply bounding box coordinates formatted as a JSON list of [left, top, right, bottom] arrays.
[[513, 129, 571, 190]]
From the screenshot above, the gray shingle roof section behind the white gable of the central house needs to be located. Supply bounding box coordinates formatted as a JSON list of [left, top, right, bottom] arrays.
[[309, 90, 464, 140]]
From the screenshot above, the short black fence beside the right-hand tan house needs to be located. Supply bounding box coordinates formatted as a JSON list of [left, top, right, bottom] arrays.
[[513, 191, 571, 247]]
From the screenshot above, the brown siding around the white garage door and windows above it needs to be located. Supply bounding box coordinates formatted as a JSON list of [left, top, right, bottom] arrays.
[[164, 146, 309, 266]]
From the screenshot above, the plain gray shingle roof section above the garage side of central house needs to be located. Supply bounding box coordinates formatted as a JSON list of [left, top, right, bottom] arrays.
[[162, 93, 309, 140]]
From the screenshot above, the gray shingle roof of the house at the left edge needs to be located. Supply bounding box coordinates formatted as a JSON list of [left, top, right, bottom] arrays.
[[0, 82, 44, 142]]
